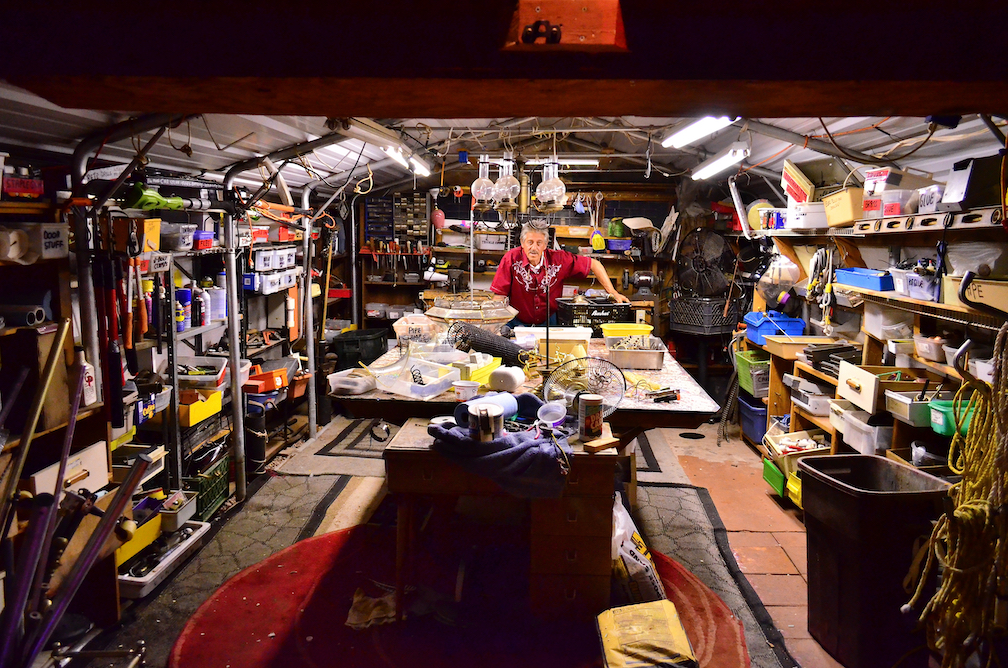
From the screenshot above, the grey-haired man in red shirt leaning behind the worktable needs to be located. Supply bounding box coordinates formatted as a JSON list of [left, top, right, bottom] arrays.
[[490, 222, 630, 327]]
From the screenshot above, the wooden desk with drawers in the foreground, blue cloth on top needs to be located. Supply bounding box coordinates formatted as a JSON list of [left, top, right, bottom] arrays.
[[383, 418, 626, 620]]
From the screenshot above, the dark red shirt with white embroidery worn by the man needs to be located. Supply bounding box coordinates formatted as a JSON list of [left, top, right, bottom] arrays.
[[490, 248, 592, 324]]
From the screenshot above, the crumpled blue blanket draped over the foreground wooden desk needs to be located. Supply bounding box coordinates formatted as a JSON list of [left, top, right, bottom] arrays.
[[427, 395, 571, 499]]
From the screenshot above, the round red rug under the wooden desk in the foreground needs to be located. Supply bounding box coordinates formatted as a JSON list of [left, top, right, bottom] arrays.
[[168, 525, 749, 668]]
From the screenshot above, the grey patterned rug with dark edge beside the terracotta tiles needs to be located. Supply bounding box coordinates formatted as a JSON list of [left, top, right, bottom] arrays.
[[634, 483, 797, 668]]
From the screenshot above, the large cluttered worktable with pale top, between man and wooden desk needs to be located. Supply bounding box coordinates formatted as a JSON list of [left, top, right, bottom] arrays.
[[330, 339, 720, 444]]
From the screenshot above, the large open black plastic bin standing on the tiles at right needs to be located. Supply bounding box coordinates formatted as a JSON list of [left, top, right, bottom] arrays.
[[798, 454, 949, 668]]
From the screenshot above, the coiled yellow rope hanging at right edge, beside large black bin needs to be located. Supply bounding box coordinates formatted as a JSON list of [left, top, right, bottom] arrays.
[[903, 323, 1008, 668]]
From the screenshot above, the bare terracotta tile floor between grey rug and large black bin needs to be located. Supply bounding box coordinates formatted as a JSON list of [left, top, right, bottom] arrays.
[[673, 428, 840, 668]]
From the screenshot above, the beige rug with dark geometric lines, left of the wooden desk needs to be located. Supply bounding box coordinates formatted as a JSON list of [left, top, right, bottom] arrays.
[[277, 417, 399, 477]]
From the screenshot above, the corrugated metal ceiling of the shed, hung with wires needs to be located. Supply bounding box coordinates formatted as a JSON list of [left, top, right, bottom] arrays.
[[0, 82, 1004, 199]]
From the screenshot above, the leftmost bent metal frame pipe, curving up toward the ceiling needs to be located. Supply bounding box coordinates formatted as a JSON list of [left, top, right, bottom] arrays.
[[70, 114, 187, 395]]
